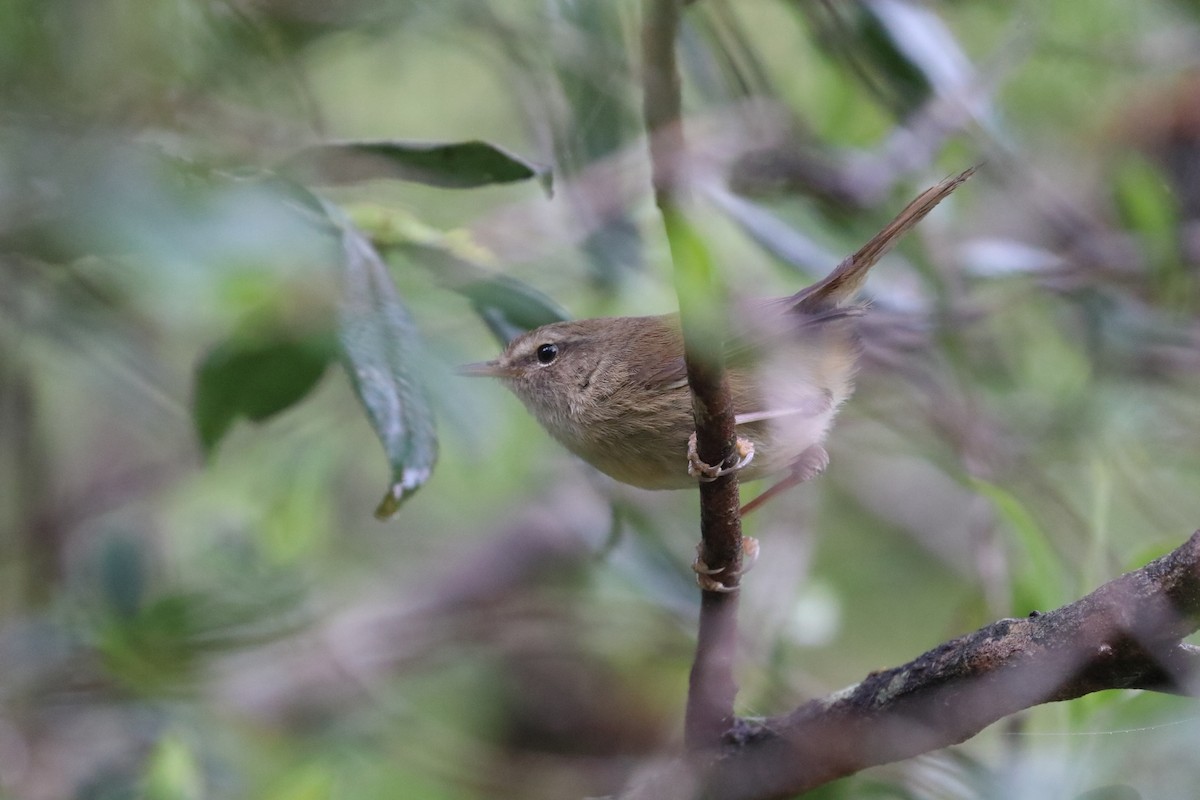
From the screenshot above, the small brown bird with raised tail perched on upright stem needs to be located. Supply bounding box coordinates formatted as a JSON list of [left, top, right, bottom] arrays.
[[460, 168, 974, 512]]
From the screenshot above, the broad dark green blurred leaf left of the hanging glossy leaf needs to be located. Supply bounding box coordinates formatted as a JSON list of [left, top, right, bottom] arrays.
[[192, 332, 334, 457]]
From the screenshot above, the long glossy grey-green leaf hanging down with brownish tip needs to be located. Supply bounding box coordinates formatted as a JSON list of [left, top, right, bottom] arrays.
[[326, 205, 438, 519]]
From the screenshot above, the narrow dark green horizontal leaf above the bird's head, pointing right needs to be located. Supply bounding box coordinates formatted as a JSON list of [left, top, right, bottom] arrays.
[[284, 140, 552, 196]]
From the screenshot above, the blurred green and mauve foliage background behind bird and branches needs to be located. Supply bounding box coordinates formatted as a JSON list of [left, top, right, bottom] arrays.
[[7, 0, 1200, 800]]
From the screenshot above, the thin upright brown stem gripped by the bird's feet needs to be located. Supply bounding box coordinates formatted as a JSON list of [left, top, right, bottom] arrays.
[[642, 0, 742, 751]]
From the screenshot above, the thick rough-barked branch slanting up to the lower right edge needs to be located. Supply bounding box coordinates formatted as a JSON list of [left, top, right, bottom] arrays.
[[703, 531, 1200, 800]]
